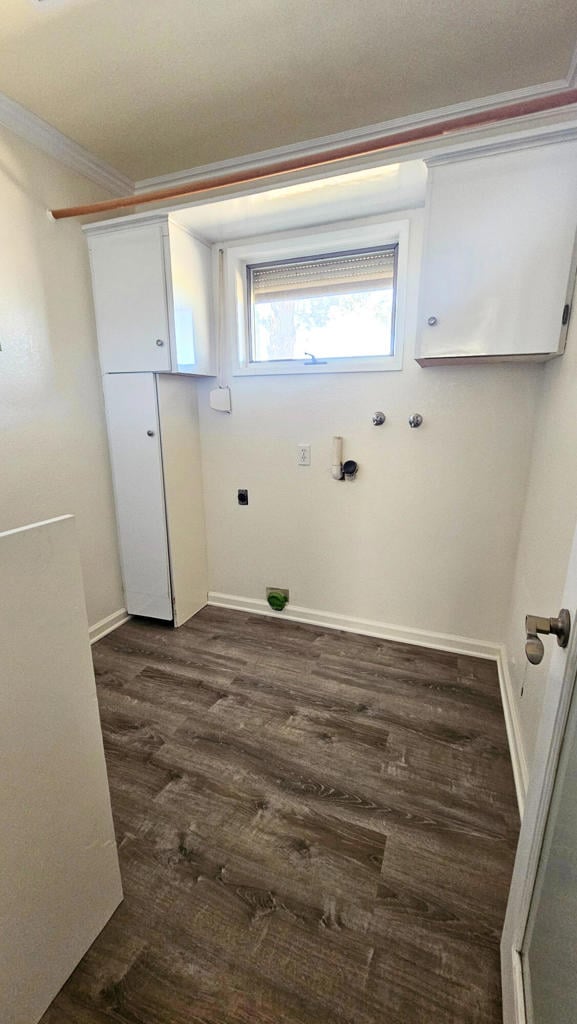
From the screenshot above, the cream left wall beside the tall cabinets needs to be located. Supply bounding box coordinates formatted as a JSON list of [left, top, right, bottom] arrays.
[[0, 123, 123, 625]]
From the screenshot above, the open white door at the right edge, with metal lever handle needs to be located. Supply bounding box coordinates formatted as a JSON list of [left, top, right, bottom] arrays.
[[501, 520, 577, 1024]]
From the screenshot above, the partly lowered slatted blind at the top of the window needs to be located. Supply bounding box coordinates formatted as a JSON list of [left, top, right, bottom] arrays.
[[247, 245, 399, 303]]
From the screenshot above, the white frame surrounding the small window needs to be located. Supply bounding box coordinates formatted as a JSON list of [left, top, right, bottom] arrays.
[[221, 217, 409, 377]]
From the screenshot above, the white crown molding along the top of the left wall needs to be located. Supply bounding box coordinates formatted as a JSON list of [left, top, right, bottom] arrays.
[[0, 93, 134, 196]]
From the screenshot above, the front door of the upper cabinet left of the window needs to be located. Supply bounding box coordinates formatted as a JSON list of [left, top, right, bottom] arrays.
[[88, 224, 171, 373]]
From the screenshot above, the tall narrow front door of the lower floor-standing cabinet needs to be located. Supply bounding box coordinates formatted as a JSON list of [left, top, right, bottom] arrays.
[[104, 374, 172, 620]]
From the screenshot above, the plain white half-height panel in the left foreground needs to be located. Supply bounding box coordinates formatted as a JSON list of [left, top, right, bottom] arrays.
[[0, 516, 122, 1024]]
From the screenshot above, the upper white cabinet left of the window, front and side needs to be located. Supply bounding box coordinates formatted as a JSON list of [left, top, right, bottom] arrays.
[[86, 215, 214, 375]]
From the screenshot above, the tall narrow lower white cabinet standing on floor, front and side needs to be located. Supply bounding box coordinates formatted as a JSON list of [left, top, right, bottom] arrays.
[[104, 373, 208, 626]]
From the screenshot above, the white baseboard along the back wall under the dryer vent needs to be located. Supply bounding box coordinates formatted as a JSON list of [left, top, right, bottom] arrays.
[[208, 592, 500, 662]]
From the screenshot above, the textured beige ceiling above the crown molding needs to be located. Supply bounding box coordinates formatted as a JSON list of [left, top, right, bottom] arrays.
[[0, 0, 577, 178]]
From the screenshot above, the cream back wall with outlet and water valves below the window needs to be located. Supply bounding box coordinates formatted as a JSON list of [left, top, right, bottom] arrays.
[[200, 211, 543, 641]]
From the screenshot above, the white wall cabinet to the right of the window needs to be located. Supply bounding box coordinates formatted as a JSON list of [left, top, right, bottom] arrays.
[[416, 142, 577, 366]]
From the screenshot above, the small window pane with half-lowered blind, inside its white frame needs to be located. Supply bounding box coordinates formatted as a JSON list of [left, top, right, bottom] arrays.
[[246, 245, 399, 362]]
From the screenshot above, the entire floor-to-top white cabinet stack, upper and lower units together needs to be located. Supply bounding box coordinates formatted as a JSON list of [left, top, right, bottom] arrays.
[[85, 215, 213, 626]]
